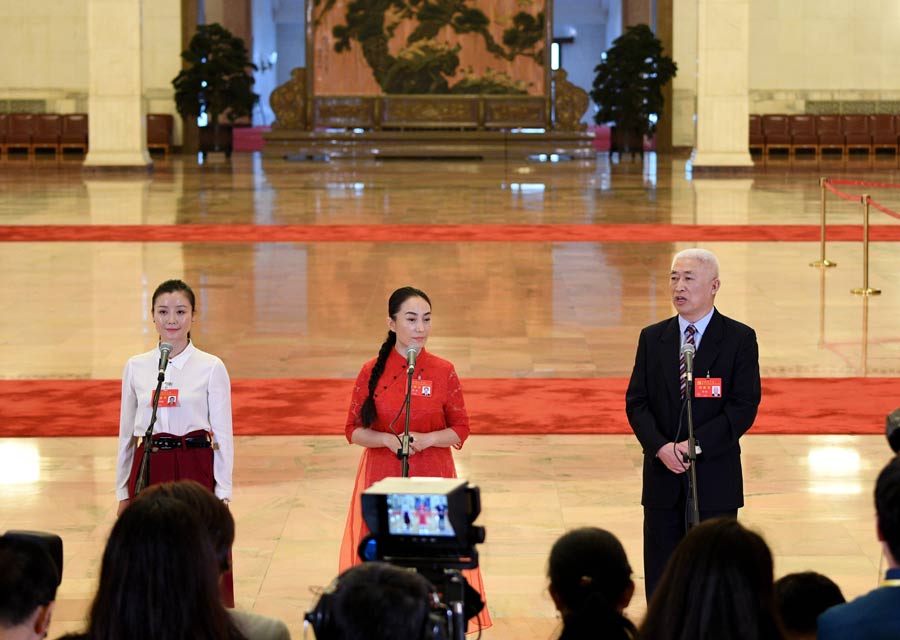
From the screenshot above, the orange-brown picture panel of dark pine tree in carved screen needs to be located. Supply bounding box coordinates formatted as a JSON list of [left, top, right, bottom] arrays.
[[307, 0, 551, 97]]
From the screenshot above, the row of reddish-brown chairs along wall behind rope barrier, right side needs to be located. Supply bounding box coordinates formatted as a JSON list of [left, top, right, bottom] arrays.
[[750, 114, 900, 157]]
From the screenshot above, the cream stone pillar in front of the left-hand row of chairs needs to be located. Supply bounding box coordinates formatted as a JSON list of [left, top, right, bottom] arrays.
[[84, 0, 153, 170]]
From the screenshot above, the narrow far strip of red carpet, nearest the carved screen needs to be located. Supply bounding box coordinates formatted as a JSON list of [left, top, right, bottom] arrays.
[[0, 224, 900, 243]]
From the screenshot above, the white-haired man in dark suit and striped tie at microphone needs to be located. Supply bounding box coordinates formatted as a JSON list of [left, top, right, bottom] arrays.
[[625, 249, 760, 600]]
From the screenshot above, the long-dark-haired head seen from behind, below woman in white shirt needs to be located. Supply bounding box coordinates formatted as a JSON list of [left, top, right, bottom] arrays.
[[59, 493, 246, 640]]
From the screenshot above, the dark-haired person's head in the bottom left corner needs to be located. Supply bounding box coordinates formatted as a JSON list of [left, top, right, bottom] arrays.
[[0, 535, 59, 640]]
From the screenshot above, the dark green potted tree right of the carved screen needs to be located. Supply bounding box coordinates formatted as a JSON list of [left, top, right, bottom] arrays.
[[591, 24, 678, 158]]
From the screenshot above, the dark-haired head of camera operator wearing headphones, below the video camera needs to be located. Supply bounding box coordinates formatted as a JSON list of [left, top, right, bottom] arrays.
[[305, 562, 447, 640]]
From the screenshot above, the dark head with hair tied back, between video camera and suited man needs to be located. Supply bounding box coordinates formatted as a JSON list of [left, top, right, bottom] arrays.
[[547, 527, 637, 640]]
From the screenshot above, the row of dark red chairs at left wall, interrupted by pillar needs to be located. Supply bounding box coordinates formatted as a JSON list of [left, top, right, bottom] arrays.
[[0, 113, 175, 159]]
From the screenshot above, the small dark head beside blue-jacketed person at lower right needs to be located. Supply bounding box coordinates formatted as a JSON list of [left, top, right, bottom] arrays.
[[775, 571, 845, 640]]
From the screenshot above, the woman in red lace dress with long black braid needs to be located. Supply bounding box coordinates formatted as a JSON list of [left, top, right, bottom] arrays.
[[340, 287, 491, 628]]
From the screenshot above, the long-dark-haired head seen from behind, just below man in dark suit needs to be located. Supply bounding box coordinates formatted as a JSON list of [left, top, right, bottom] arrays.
[[640, 518, 784, 640]]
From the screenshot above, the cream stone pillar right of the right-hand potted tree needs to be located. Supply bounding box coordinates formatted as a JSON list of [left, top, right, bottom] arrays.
[[691, 0, 753, 173]]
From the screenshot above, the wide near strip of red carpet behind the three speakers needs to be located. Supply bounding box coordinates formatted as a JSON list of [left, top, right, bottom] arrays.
[[0, 378, 900, 436]]
